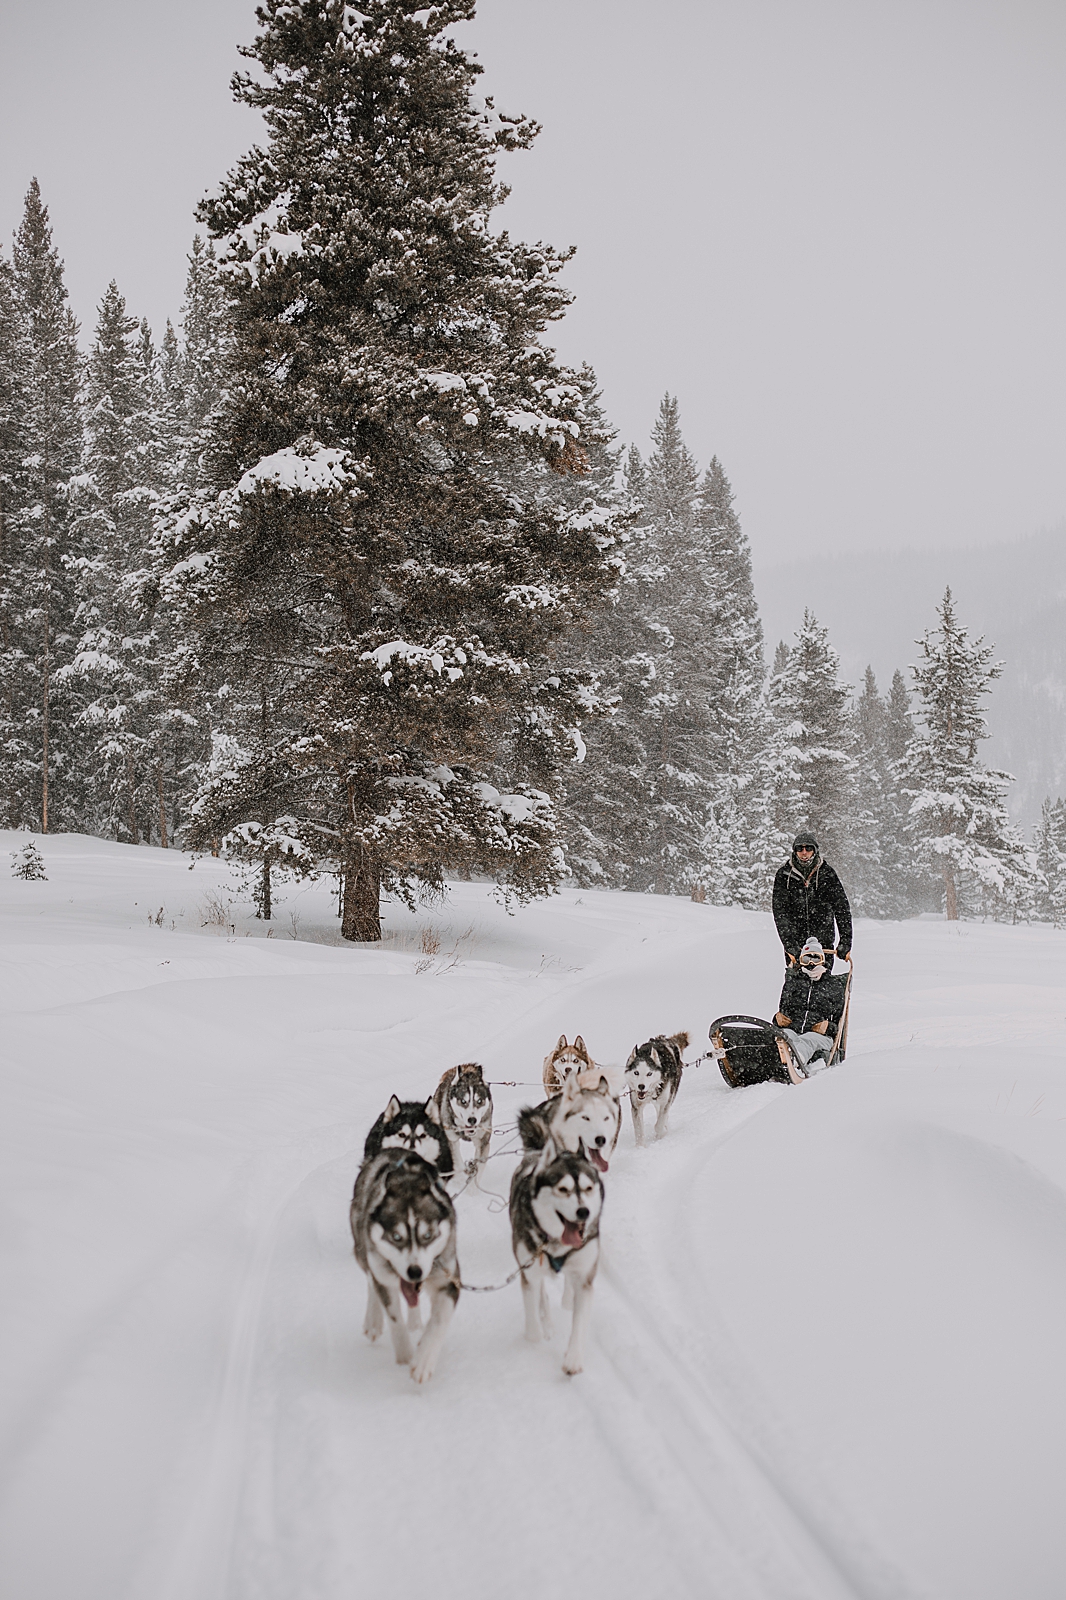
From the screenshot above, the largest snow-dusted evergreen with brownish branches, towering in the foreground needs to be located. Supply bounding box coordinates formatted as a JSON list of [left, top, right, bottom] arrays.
[[168, 0, 618, 939]]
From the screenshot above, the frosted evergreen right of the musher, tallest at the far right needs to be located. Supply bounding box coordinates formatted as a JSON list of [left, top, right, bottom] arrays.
[[898, 589, 1037, 922]]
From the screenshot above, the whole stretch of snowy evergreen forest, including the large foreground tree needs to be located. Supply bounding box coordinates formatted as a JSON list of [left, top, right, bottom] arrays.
[[0, 0, 1043, 941]]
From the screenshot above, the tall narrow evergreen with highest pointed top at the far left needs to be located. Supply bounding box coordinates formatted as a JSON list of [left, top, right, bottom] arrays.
[[5, 179, 85, 834]]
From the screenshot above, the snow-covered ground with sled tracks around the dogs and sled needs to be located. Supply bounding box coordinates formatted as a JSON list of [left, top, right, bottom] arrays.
[[0, 835, 1066, 1600]]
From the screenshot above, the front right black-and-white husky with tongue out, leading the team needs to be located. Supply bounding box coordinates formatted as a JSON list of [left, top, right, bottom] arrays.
[[511, 1139, 603, 1376]]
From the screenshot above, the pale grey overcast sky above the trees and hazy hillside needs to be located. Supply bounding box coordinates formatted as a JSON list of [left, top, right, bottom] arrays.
[[0, 0, 1066, 563]]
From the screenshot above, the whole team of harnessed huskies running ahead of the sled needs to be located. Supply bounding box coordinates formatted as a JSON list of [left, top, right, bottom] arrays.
[[351, 1034, 688, 1384]]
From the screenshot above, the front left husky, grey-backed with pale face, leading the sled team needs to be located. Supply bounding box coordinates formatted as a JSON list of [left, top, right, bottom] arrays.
[[351, 1147, 459, 1384]]
